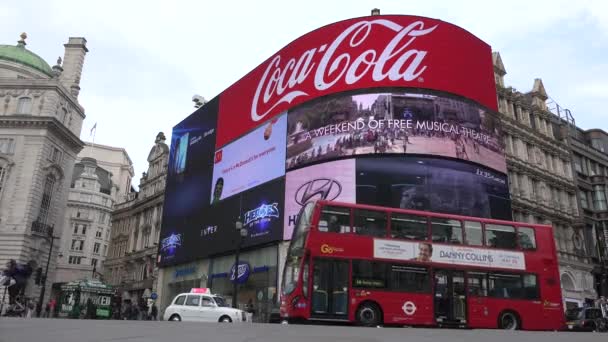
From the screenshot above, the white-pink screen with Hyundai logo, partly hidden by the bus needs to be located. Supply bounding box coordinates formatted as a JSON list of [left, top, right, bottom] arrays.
[[283, 159, 356, 240]]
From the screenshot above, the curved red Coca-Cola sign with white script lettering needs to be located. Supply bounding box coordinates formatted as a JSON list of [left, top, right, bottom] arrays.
[[216, 15, 497, 147]]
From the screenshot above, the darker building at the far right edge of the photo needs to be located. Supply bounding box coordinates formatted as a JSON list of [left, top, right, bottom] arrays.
[[569, 125, 608, 297]]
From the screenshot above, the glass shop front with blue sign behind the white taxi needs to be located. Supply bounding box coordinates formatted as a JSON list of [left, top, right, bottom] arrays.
[[208, 245, 279, 322]]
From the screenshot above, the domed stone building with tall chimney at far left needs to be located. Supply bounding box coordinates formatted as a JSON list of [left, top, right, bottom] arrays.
[[0, 33, 88, 304]]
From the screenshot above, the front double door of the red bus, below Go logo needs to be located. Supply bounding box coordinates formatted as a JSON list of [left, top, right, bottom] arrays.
[[310, 258, 349, 319]]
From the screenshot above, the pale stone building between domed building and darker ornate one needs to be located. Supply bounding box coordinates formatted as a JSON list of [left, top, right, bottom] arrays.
[[53, 143, 133, 290]]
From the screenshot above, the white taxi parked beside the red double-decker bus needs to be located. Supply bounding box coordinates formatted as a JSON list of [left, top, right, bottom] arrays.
[[163, 289, 247, 323]]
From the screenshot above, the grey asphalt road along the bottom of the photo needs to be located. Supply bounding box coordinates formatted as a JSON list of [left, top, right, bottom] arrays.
[[0, 317, 608, 342]]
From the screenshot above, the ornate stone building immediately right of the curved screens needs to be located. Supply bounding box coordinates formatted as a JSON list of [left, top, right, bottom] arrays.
[[493, 52, 596, 306]]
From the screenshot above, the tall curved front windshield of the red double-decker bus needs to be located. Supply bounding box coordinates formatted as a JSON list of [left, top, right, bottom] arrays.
[[281, 202, 315, 294]]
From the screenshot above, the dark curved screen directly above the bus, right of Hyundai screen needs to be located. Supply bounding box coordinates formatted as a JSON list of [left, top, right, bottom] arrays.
[[356, 156, 512, 220]]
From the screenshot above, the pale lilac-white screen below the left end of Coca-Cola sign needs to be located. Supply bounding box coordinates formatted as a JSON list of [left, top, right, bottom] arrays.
[[210, 115, 287, 204]]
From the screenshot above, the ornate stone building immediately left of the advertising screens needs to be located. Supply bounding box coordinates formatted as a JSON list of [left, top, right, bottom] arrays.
[[104, 132, 169, 304]]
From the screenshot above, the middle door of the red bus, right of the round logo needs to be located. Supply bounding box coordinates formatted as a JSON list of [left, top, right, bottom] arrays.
[[434, 270, 467, 324]]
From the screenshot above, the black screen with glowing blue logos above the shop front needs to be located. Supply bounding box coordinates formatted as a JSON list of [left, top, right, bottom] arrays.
[[158, 177, 285, 265]]
